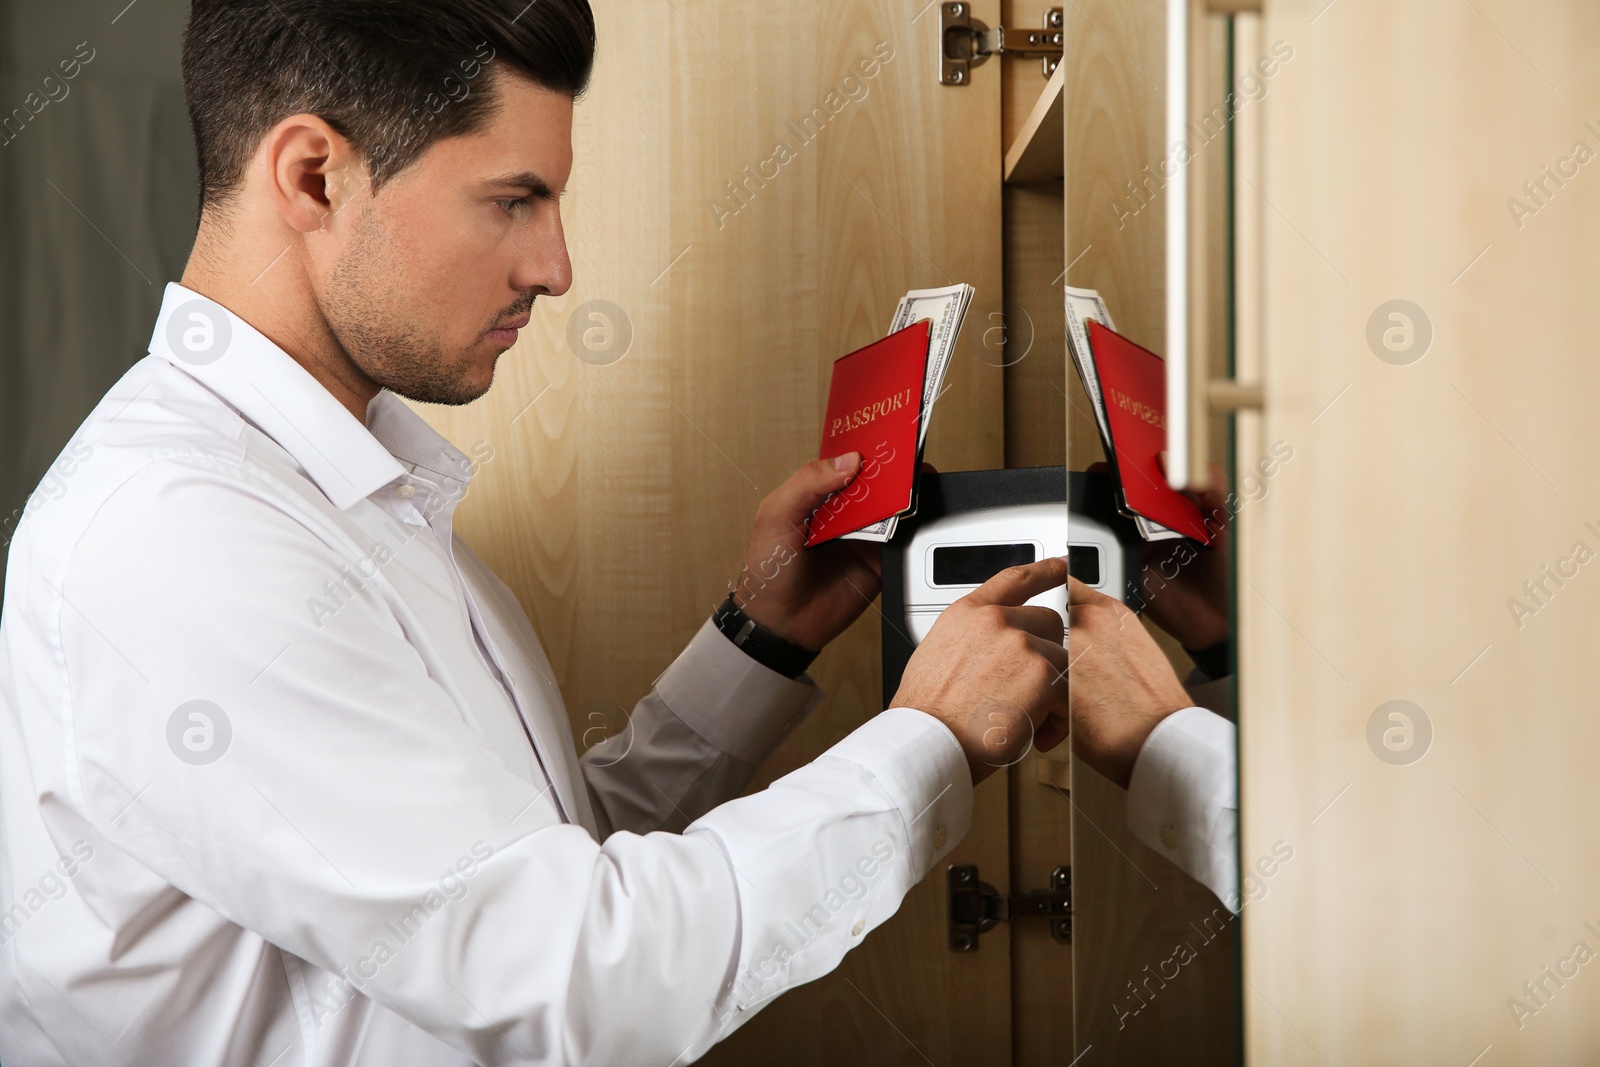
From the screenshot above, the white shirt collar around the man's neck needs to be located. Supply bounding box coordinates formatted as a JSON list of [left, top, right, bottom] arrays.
[[150, 282, 472, 510]]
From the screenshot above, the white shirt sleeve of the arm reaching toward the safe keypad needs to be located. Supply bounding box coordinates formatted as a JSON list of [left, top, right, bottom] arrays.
[[51, 459, 971, 1065]]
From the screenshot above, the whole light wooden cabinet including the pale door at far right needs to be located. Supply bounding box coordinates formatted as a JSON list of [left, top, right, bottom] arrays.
[[429, 0, 1600, 1067]]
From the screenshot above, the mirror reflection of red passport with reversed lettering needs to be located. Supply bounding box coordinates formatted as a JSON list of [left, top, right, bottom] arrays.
[[1088, 320, 1211, 544]]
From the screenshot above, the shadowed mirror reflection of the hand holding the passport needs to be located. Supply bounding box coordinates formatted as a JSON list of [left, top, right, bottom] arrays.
[[1139, 464, 1234, 651]]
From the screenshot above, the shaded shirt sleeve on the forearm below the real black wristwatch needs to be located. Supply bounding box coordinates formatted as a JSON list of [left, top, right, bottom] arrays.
[[582, 619, 822, 837]]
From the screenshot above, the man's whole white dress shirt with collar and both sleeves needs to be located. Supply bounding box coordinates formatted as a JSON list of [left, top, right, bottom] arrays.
[[0, 285, 971, 1067]]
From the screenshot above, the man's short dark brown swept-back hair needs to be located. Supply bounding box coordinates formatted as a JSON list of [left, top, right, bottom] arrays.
[[184, 0, 595, 210]]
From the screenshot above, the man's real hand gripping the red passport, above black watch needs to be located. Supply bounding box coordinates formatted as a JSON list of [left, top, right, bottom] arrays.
[[733, 453, 902, 651]]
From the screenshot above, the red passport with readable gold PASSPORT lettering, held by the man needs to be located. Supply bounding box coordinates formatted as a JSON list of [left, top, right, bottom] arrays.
[[805, 320, 928, 549]]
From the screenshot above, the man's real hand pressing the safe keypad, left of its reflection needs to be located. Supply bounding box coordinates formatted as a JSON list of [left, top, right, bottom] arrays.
[[894, 557, 1067, 785]]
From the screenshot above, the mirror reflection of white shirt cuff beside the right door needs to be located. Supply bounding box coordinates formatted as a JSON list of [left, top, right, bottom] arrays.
[[1128, 707, 1238, 912]]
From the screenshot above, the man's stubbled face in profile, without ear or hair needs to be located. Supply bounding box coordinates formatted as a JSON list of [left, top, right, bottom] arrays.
[[315, 75, 573, 405]]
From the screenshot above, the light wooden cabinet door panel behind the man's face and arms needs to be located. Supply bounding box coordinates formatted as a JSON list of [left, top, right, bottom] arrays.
[[427, 0, 1004, 1067]]
